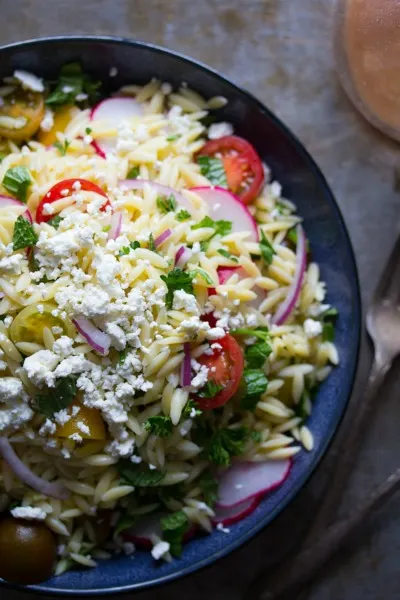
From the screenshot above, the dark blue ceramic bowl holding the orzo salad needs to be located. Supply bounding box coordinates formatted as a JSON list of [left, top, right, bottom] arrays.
[[0, 36, 361, 595]]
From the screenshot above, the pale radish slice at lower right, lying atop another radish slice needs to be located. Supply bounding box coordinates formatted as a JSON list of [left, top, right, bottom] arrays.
[[217, 459, 291, 508]]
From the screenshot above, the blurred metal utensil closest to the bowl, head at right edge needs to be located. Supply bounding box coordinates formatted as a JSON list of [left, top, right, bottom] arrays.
[[247, 231, 400, 600]]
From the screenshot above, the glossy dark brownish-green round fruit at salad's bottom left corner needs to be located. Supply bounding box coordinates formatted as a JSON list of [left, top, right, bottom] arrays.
[[0, 517, 56, 585]]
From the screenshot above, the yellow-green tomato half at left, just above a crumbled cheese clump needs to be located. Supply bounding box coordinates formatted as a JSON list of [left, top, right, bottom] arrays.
[[10, 302, 76, 344]]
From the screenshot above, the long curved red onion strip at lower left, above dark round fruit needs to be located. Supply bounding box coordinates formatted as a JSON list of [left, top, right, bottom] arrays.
[[0, 436, 69, 500]]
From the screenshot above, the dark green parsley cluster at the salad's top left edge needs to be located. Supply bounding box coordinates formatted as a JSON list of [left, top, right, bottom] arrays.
[[45, 62, 101, 106]]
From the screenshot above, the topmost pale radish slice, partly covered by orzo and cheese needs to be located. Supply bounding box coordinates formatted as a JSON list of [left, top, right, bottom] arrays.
[[90, 98, 143, 158]]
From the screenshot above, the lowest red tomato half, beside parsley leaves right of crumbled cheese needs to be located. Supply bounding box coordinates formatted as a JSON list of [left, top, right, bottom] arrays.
[[195, 334, 244, 410]]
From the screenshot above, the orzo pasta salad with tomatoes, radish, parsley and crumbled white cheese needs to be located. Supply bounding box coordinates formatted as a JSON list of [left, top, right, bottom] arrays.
[[0, 64, 338, 583]]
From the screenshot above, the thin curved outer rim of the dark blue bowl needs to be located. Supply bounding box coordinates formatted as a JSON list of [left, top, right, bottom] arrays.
[[0, 34, 362, 596]]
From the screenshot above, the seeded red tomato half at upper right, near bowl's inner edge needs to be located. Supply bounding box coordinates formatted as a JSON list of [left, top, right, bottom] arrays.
[[196, 135, 264, 204]]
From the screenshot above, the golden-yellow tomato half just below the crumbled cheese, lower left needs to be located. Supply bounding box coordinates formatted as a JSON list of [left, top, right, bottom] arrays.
[[56, 401, 106, 440]]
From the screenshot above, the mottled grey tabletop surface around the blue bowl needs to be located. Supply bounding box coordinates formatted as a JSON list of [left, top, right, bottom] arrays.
[[0, 0, 400, 600]]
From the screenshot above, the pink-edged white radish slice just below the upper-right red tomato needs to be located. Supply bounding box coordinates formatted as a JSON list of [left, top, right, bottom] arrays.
[[190, 187, 258, 242]]
